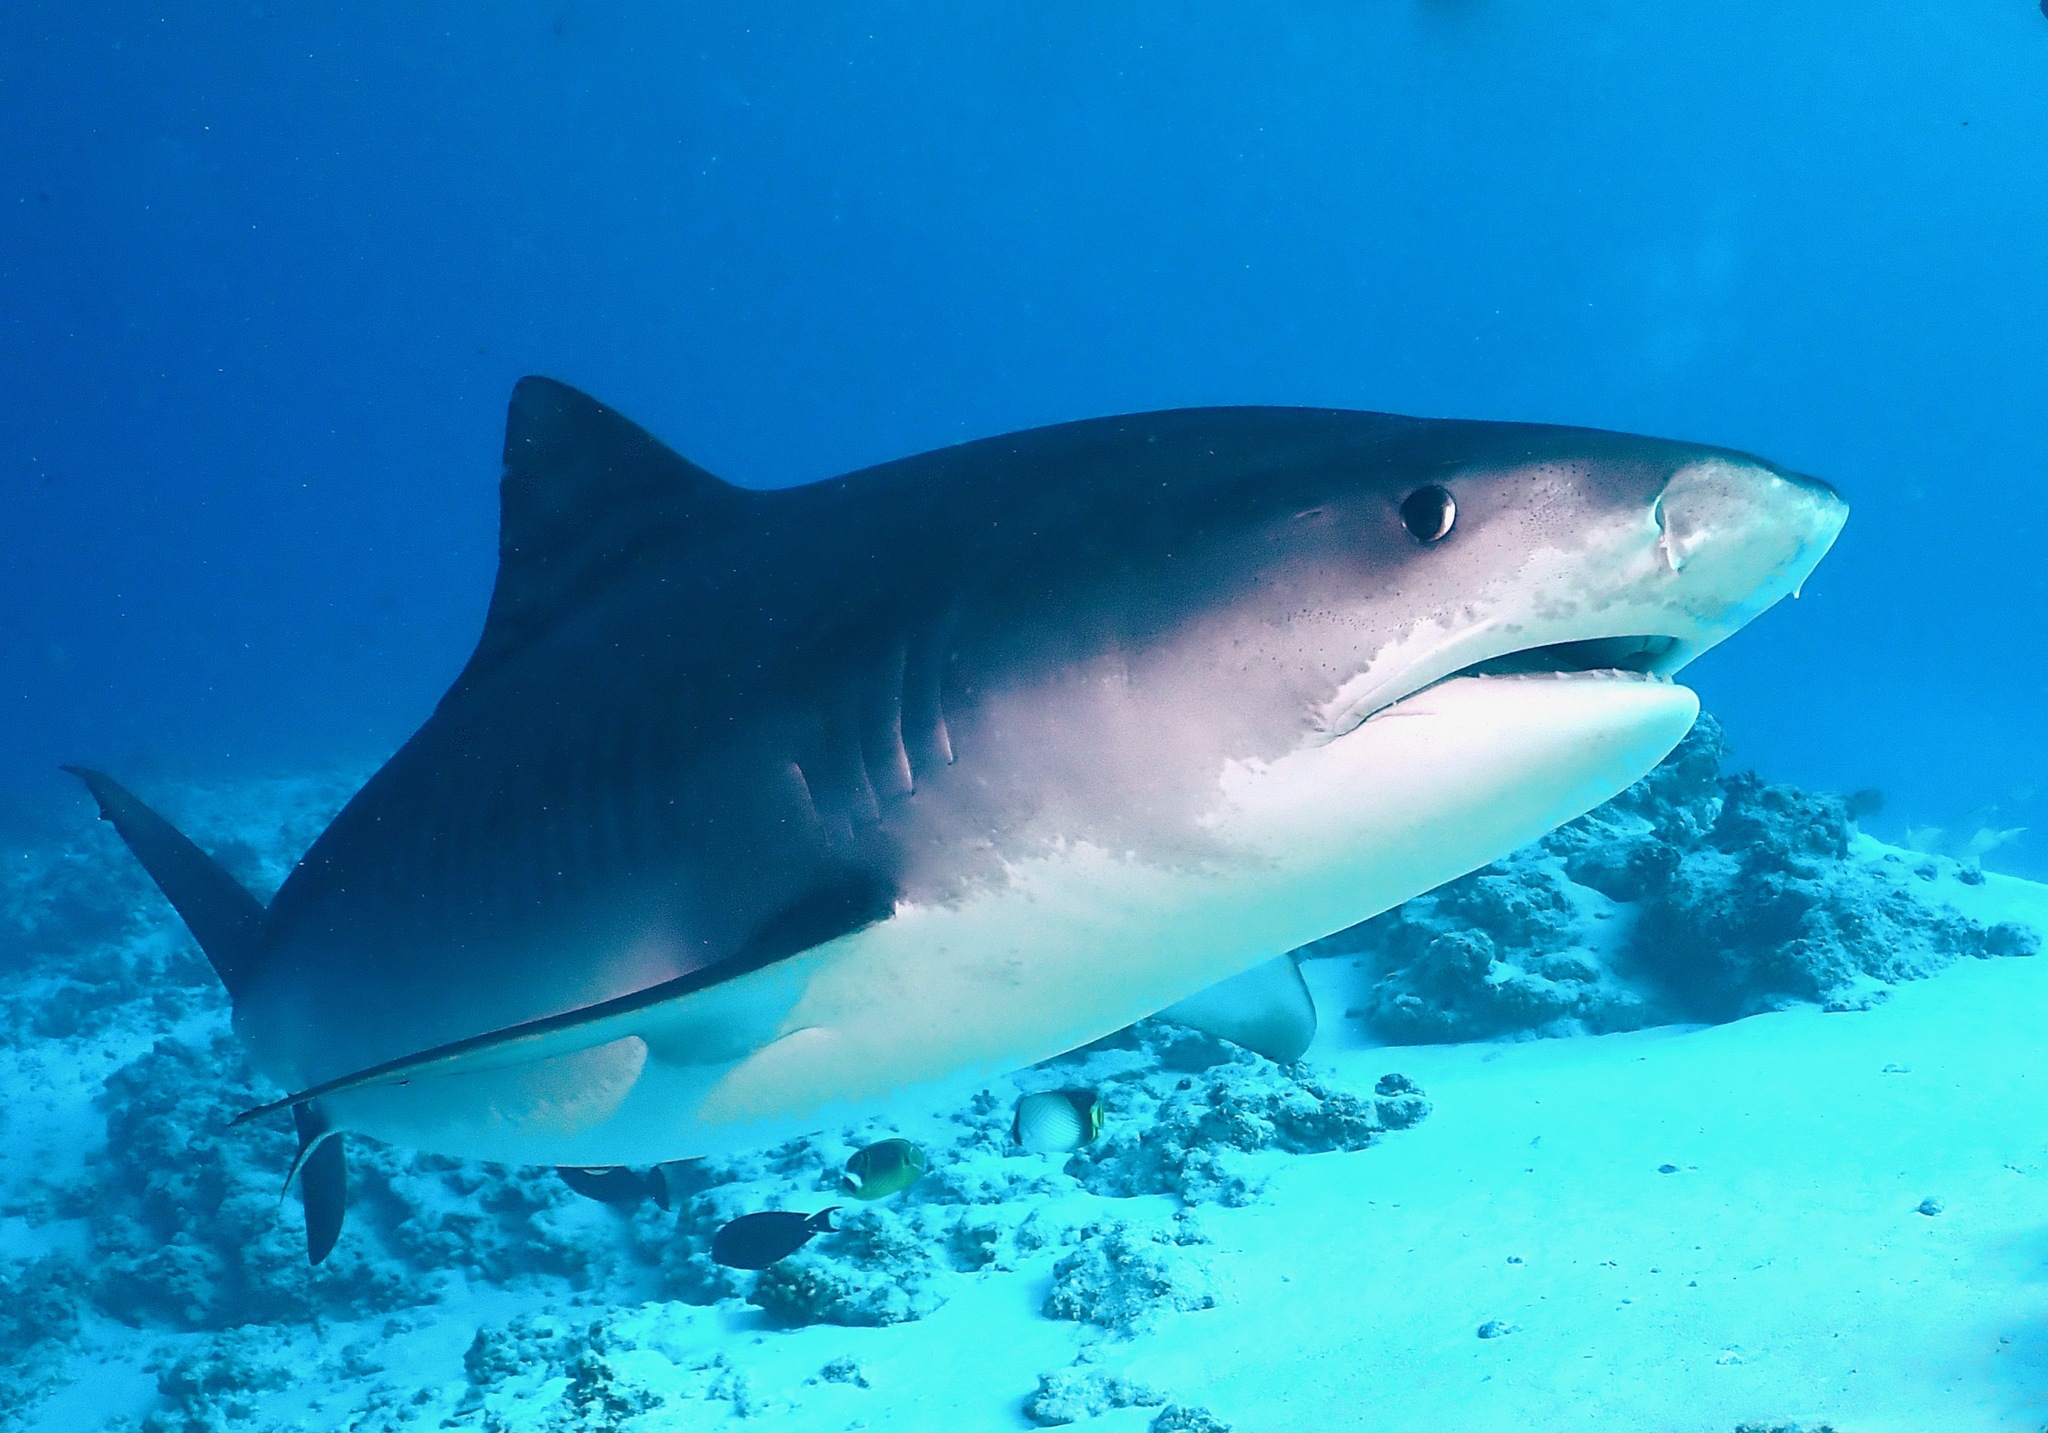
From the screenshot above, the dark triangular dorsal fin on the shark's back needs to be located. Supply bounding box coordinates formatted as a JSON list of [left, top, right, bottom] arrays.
[[475, 377, 752, 675]]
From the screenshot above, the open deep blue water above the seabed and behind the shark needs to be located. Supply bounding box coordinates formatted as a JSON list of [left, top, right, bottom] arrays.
[[0, 0, 2048, 862]]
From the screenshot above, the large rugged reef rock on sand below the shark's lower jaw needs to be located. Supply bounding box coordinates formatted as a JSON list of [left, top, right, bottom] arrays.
[[1307, 717, 2038, 1042]]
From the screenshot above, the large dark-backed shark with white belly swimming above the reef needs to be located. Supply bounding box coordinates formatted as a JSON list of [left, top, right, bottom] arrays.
[[74, 379, 1847, 1263]]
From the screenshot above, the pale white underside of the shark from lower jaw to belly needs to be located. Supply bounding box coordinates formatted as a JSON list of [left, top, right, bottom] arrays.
[[328, 671, 1700, 1165]]
